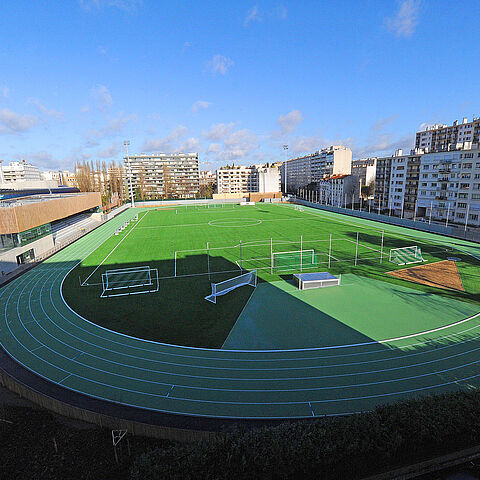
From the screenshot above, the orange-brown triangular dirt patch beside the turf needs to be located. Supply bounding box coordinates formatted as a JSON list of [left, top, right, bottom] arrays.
[[387, 260, 465, 292]]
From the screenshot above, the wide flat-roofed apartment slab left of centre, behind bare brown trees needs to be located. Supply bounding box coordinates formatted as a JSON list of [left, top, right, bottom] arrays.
[[124, 153, 200, 199]]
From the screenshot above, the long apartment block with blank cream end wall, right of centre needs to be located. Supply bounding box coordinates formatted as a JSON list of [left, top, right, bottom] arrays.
[[282, 145, 352, 192]]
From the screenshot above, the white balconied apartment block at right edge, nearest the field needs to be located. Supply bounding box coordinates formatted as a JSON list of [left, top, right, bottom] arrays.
[[417, 148, 480, 226]]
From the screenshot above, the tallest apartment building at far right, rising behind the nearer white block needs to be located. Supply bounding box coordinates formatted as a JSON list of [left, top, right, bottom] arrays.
[[415, 117, 480, 153]]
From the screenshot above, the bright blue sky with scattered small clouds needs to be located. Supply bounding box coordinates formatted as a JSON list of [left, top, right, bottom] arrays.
[[0, 0, 480, 169]]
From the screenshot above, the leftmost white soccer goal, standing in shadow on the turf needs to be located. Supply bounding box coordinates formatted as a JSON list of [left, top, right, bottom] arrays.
[[100, 266, 158, 298]]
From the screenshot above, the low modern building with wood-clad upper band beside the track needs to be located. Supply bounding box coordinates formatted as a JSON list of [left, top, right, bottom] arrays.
[[0, 192, 102, 274]]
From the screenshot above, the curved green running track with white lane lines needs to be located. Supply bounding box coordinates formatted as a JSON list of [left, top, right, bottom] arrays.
[[0, 211, 480, 419]]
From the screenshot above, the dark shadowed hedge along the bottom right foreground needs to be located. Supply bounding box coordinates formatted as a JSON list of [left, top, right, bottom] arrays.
[[130, 391, 480, 480]]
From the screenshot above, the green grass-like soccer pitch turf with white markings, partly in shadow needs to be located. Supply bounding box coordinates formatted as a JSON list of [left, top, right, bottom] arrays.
[[63, 204, 480, 348]]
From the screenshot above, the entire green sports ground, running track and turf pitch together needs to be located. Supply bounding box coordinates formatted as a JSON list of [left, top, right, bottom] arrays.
[[0, 205, 480, 418]]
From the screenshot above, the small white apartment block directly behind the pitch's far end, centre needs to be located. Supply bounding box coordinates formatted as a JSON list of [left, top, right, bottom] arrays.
[[217, 165, 281, 193]]
